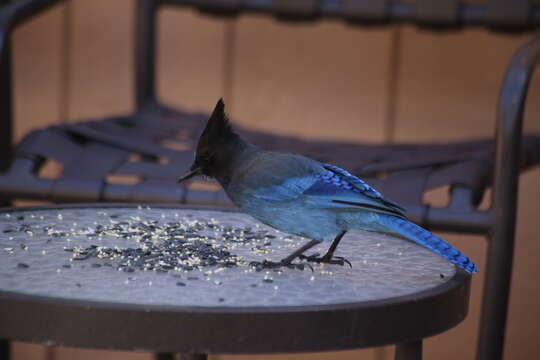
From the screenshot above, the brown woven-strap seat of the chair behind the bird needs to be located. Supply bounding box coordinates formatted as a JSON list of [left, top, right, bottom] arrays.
[[0, 105, 540, 228]]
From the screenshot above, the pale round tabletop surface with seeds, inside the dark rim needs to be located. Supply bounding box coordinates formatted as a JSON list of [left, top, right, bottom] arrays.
[[0, 206, 455, 306]]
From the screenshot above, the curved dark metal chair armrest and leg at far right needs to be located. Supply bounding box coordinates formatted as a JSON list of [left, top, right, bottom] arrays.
[[478, 35, 540, 360]]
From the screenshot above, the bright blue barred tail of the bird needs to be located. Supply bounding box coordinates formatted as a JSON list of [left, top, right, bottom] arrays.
[[379, 215, 478, 274]]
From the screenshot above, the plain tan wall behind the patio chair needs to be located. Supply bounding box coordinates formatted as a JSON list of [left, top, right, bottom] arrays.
[[7, 0, 540, 360]]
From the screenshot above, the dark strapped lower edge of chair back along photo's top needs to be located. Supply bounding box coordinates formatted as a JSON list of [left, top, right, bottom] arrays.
[[162, 0, 540, 32]]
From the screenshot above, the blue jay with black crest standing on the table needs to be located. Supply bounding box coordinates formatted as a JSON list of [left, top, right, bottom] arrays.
[[178, 99, 478, 274]]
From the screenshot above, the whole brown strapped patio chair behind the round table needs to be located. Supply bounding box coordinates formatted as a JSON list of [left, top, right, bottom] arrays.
[[0, 0, 540, 359]]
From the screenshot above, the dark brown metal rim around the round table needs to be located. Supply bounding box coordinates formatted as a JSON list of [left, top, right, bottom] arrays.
[[0, 203, 471, 360]]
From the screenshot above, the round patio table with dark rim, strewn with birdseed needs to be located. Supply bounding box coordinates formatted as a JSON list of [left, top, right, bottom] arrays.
[[0, 204, 469, 353]]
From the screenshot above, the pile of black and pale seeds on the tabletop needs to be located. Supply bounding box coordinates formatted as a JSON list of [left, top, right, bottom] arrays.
[[53, 220, 275, 272]]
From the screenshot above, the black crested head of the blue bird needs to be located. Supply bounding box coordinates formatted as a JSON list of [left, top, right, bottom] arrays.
[[178, 99, 241, 182]]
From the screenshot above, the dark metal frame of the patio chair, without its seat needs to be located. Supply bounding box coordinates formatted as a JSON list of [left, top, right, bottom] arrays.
[[0, 0, 540, 360]]
